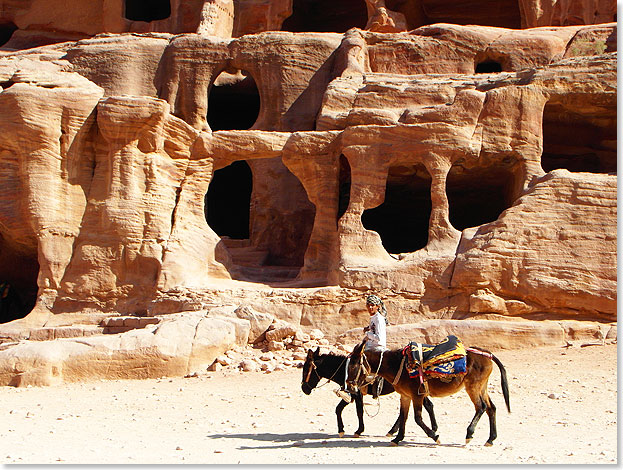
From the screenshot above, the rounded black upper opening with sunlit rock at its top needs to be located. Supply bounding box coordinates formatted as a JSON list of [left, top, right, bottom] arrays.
[[206, 72, 260, 131]]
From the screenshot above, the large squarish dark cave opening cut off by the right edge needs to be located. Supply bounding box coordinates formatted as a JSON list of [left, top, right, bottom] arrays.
[[541, 103, 617, 174]]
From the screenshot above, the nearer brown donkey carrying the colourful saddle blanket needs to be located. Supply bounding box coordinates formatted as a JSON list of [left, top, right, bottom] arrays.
[[347, 341, 511, 446]]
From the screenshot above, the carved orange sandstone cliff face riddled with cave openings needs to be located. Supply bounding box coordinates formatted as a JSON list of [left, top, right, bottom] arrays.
[[0, 0, 617, 382]]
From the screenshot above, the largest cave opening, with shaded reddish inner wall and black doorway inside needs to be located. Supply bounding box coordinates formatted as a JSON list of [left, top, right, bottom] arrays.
[[205, 158, 315, 283]]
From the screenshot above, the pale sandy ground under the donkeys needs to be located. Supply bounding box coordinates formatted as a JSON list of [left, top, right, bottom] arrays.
[[0, 344, 617, 465]]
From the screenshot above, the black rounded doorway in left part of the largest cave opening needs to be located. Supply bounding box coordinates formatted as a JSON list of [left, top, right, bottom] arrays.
[[204, 160, 253, 240]]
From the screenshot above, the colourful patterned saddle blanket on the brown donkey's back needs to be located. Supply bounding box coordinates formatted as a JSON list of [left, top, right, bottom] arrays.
[[402, 335, 467, 379]]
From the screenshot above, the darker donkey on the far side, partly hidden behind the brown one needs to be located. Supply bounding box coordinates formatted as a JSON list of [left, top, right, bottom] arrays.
[[301, 348, 437, 437]]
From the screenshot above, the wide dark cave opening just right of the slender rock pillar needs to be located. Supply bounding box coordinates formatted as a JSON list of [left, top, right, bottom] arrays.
[[446, 157, 516, 231]]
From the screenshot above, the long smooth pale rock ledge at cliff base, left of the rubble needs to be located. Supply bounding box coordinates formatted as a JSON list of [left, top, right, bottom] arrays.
[[0, 314, 250, 386]]
